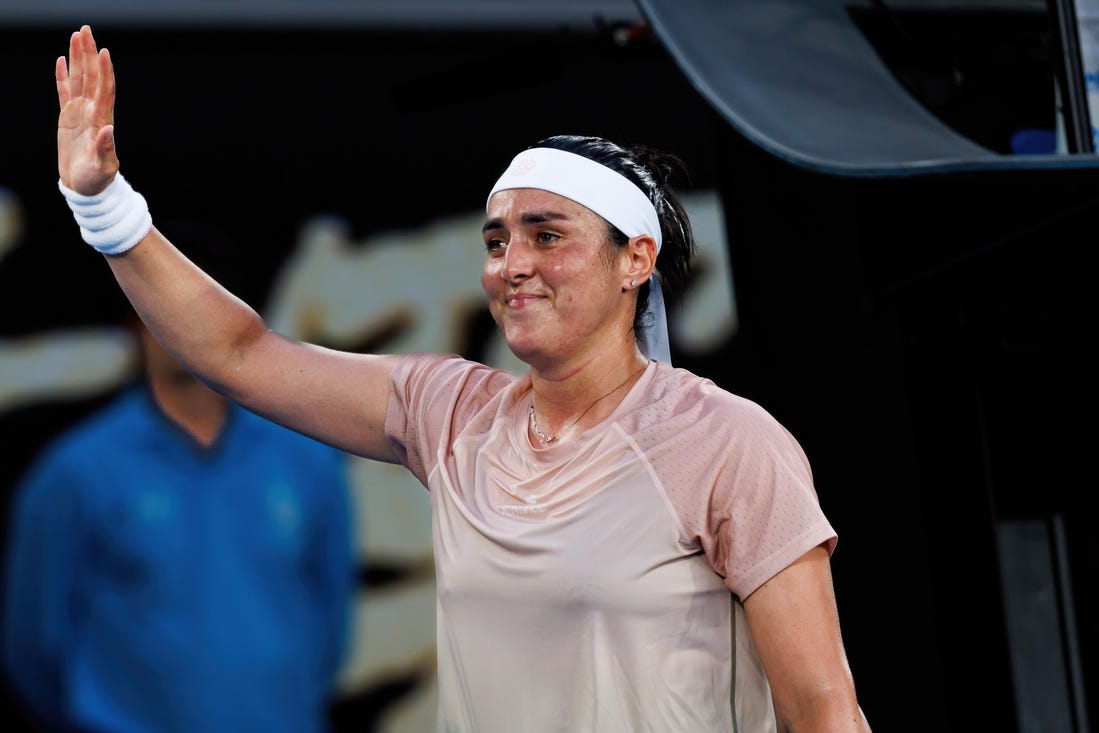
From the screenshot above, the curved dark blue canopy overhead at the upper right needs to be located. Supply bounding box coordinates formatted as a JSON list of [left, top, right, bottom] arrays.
[[640, 0, 1099, 175]]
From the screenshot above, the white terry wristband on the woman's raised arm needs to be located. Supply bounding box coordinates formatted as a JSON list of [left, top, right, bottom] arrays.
[[57, 173, 153, 255]]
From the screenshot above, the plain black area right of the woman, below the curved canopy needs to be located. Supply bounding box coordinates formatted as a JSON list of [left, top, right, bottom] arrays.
[[721, 129, 1099, 731]]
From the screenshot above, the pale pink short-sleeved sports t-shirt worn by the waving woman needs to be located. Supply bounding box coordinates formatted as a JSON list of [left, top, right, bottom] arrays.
[[386, 354, 836, 733]]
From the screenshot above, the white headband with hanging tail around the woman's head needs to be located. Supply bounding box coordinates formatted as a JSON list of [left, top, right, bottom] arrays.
[[485, 147, 671, 364]]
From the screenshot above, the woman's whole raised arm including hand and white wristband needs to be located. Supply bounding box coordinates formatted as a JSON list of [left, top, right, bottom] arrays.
[[55, 25, 396, 462]]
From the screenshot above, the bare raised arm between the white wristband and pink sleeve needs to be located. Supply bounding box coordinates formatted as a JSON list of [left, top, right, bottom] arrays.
[[108, 227, 397, 462]]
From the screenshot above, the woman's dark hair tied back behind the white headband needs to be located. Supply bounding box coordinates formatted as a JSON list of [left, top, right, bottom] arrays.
[[531, 135, 695, 334]]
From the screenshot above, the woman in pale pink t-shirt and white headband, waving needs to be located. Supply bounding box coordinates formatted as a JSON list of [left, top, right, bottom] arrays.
[[56, 26, 869, 733]]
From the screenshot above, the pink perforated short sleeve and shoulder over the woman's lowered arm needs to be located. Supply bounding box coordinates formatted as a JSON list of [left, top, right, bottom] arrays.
[[631, 369, 836, 599]]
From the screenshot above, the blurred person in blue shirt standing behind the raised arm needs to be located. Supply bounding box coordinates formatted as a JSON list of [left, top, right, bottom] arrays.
[[3, 220, 355, 733]]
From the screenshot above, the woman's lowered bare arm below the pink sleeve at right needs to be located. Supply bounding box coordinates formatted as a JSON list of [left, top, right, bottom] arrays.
[[744, 546, 869, 731]]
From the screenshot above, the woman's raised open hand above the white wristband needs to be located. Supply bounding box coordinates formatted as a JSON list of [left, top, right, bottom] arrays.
[[54, 25, 119, 196]]
